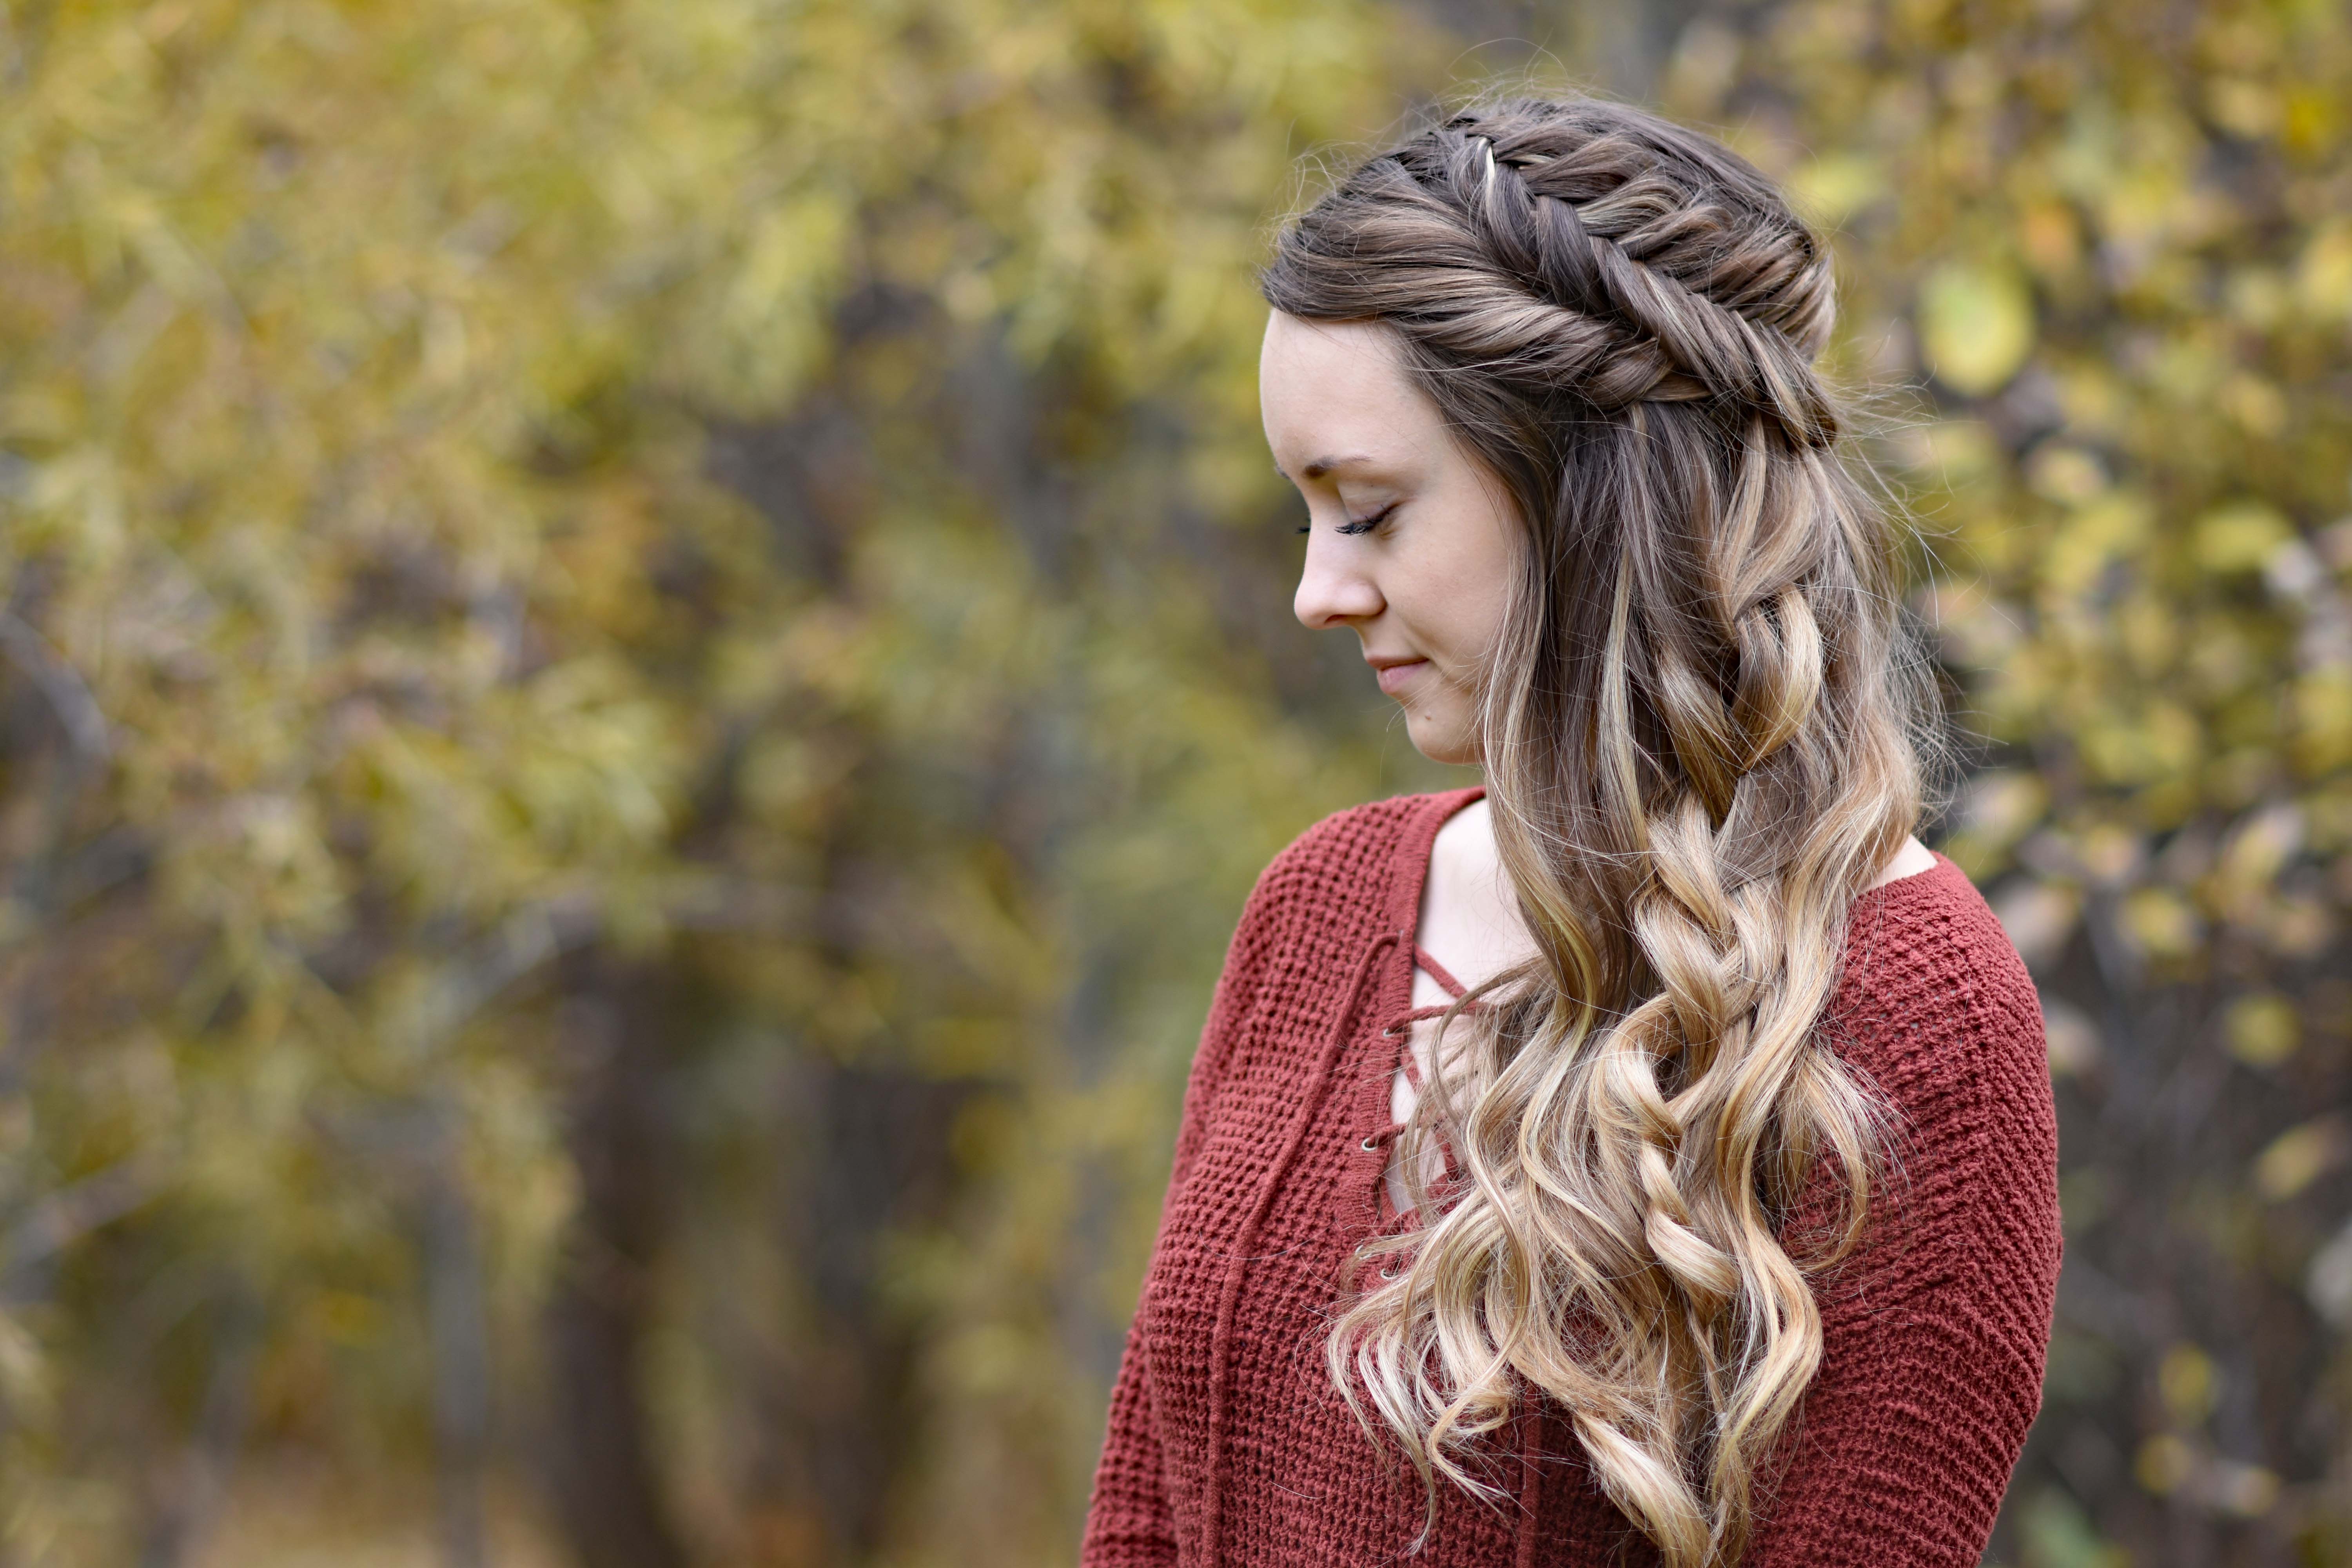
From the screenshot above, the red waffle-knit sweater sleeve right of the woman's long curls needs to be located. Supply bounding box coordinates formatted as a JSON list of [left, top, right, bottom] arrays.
[[1745, 888, 2060, 1568]]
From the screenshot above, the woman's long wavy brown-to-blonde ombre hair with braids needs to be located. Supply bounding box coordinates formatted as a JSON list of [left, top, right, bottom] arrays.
[[1263, 99, 1931, 1568]]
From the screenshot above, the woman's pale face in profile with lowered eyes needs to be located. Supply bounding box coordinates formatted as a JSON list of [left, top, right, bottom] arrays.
[[1258, 310, 1519, 762]]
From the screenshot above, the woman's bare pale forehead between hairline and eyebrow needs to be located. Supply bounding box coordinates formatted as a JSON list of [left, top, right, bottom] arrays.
[[1258, 310, 1444, 479]]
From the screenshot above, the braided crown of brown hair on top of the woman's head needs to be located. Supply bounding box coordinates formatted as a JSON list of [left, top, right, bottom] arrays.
[[1277, 103, 1837, 446]]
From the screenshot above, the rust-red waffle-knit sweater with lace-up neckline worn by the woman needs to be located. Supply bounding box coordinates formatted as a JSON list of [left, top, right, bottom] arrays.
[[1082, 790, 2058, 1568]]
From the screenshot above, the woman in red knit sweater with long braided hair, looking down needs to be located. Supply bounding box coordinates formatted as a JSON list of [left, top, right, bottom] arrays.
[[1084, 101, 2058, 1568]]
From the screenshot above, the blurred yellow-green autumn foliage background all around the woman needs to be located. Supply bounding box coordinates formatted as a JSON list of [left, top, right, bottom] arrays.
[[0, 0, 2352, 1568]]
